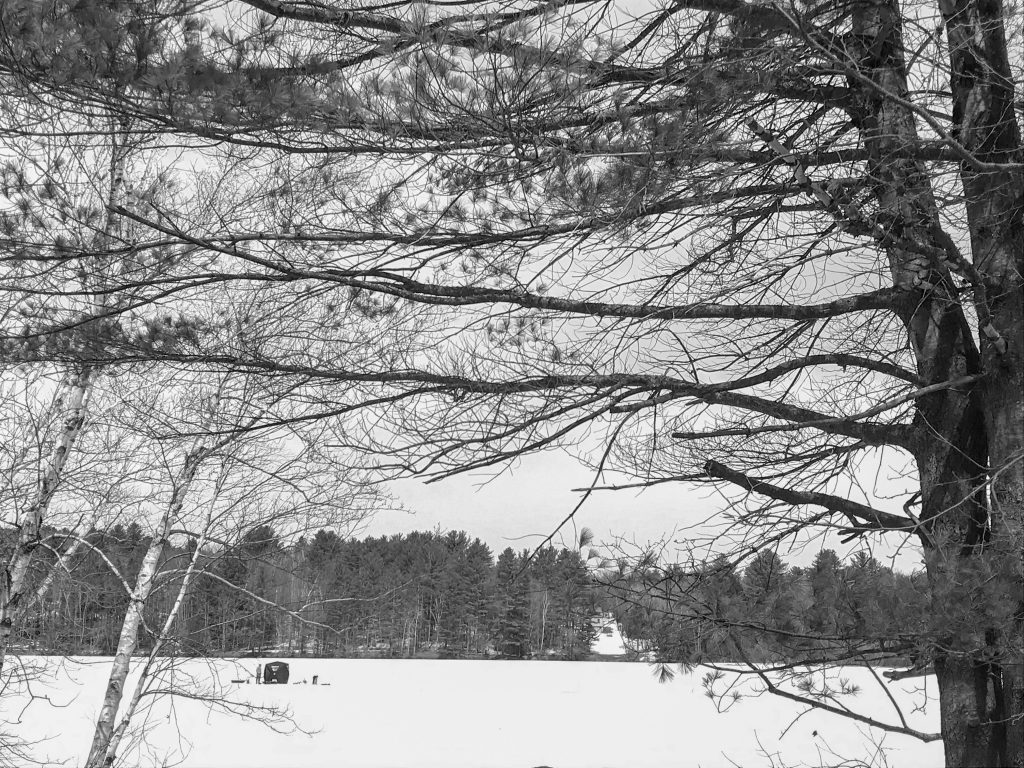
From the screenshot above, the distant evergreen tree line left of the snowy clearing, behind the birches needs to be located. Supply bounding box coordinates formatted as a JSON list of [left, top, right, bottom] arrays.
[[5, 522, 597, 658]]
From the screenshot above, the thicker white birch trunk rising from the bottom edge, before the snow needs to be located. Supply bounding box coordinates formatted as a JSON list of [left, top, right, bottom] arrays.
[[85, 445, 209, 768]]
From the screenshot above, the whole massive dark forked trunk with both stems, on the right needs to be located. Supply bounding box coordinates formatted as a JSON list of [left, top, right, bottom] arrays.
[[850, 0, 1024, 768]]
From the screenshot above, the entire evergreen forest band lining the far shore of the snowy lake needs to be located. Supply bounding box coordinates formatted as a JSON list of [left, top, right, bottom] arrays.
[[7, 522, 926, 664]]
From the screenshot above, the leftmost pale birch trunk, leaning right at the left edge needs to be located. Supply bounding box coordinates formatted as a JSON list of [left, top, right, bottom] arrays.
[[0, 367, 92, 675]]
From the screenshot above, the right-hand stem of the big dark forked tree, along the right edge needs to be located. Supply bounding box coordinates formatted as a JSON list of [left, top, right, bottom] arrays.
[[939, 0, 1024, 768]]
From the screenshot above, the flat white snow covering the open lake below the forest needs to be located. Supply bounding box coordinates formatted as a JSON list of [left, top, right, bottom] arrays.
[[0, 658, 942, 768]]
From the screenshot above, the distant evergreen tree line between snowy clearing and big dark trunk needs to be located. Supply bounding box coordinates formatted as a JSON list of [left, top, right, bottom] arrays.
[[602, 549, 932, 665]]
